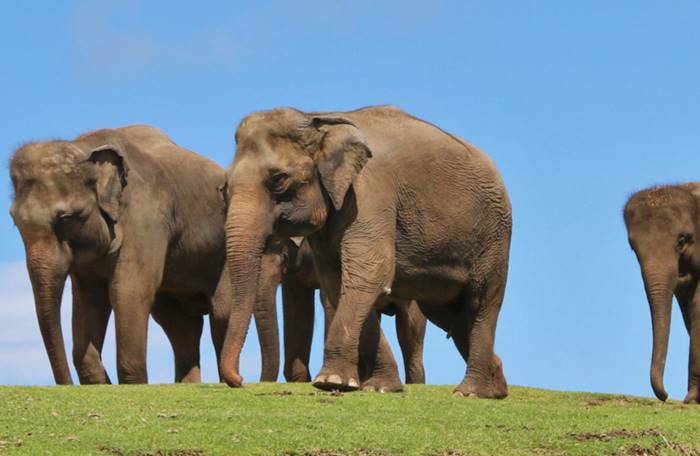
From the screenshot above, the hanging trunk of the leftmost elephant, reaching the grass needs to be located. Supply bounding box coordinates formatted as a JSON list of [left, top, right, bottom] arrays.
[[26, 235, 73, 385]]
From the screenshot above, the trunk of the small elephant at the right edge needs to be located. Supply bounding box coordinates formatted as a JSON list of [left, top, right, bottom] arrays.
[[642, 265, 678, 401]]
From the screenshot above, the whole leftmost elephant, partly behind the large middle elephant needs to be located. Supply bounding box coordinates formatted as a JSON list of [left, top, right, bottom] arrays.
[[10, 126, 277, 384]]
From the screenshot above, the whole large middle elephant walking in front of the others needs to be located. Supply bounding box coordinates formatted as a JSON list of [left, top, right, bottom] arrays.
[[221, 106, 512, 398]]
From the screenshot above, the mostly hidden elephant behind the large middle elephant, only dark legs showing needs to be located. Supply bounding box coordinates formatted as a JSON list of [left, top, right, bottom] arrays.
[[281, 239, 426, 383]]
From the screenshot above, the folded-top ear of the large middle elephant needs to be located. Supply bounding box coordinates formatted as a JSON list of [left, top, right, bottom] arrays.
[[311, 117, 372, 210]]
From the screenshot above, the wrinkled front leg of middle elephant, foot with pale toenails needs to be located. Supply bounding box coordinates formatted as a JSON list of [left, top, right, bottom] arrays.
[[313, 242, 394, 391]]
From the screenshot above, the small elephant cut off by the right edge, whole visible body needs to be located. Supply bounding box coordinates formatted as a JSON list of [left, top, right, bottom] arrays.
[[624, 183, 700, 404]]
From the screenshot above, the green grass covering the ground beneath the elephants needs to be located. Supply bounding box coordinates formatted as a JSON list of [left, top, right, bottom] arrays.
[[0, 383, 700, 456]]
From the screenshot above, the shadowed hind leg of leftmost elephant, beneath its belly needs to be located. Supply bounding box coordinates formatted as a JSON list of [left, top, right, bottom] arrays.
[[151, 295, 204, 383]]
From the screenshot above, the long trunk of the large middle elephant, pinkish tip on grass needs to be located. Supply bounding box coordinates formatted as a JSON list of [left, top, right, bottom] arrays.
[[220, 184, 272, 387]]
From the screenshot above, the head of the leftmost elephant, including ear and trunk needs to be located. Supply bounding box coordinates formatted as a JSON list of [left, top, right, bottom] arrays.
[[10, 141, 127, 384]]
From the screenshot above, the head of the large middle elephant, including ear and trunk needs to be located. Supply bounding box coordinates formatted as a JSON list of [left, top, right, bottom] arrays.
[[221, 109, 372, 386]]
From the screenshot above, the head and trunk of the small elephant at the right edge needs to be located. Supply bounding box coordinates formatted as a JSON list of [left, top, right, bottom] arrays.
[[624, 186, 700, 401]]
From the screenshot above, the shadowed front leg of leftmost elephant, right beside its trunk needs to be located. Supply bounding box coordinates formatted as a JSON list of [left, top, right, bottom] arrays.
[[71, 275, 112, 385]]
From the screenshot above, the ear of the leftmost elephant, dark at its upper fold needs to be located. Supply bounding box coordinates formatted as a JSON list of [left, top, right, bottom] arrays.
[[88, 144, 128, 223]]
